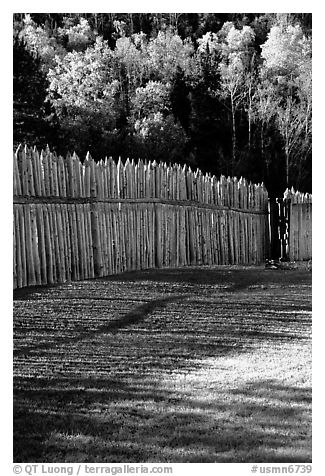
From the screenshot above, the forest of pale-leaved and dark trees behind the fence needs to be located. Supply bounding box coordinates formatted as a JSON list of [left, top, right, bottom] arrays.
[[13, 13, 312, 196]]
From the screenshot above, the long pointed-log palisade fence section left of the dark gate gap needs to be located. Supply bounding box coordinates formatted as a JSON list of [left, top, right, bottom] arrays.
[[13, 147, 269, 288]]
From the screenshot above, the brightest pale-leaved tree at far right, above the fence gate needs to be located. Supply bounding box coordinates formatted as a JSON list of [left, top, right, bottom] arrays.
[[261, 17, 312, 187]]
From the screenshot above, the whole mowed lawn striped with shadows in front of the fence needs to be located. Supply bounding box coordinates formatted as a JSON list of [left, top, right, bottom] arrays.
[[14, 266, 311, 463]]
